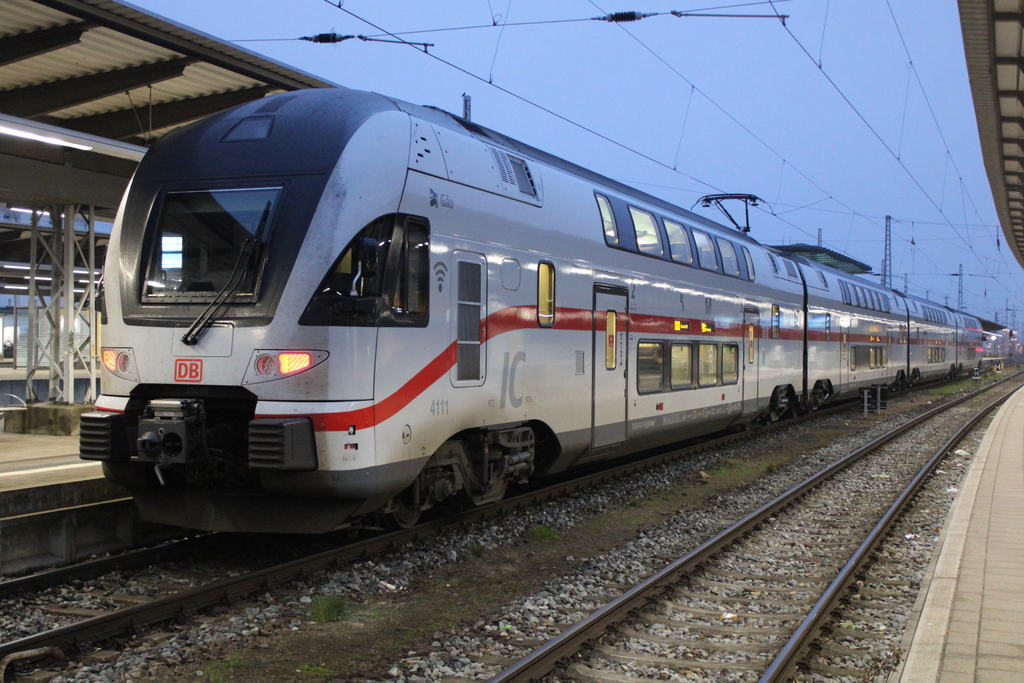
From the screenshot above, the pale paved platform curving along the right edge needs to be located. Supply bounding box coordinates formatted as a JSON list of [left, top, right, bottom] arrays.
[[890, 389, 1024, 683]]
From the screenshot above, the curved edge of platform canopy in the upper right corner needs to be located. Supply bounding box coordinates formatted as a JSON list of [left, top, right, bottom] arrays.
[[958, 0, 1024, 266]]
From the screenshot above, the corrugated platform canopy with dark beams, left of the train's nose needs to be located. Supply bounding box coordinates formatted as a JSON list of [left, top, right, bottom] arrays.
[[0, 0, 335, 290]]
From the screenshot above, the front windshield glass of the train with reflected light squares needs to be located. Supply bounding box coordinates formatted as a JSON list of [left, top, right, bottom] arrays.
[[142, 185, 285, 303]]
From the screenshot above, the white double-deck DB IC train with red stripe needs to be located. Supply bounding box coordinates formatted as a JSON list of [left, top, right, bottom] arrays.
[[80, 88, 984, 533]]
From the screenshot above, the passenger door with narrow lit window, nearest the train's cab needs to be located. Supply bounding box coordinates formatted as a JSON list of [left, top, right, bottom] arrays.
[[591, 285, 630, 449]]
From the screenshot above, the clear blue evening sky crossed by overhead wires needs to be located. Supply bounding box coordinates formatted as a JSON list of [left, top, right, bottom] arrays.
[[135, 0, 1024, 323]]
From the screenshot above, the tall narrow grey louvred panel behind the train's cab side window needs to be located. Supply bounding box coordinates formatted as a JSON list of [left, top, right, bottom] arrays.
[[450, 251, 487, 387]]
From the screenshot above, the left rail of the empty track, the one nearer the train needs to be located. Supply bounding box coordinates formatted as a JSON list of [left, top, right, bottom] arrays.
[[488, 378, 1011, 683]]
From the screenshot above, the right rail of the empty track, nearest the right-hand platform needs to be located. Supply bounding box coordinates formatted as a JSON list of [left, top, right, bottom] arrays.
[[758, 387, 1011, 683]]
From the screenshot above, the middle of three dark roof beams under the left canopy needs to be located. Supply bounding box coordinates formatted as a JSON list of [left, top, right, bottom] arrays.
[[0, 57, 195, 119]]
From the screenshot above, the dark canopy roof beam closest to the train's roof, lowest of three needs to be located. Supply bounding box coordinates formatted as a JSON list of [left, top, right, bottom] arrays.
[[47, 86, 271, 140]]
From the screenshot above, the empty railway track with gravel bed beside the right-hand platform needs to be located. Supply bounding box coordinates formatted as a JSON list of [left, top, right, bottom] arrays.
[[490, 374, 1010, 683]]
